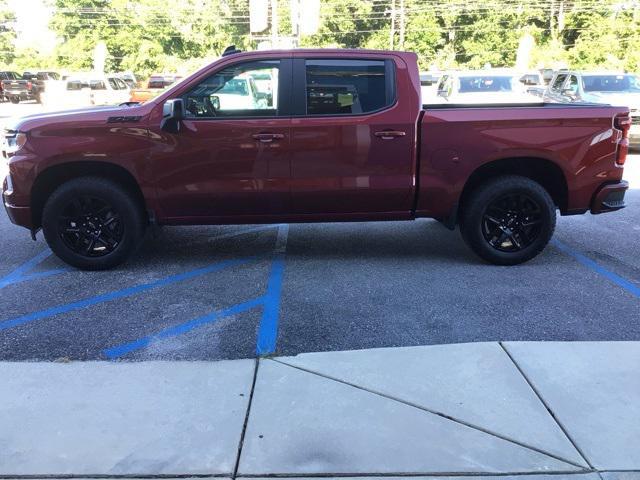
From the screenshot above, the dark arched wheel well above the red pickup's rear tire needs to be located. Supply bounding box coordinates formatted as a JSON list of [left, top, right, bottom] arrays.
[[458, 158, 568, 218]]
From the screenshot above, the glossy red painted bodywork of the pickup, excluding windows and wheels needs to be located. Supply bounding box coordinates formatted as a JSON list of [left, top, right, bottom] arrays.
[[3, 50, 627, 230]]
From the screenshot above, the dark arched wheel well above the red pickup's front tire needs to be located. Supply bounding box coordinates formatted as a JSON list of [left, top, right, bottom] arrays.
[[31, 162, 146, 228]]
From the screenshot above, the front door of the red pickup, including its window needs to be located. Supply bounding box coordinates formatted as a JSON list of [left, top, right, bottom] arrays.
[[151, 57, 291, 222]]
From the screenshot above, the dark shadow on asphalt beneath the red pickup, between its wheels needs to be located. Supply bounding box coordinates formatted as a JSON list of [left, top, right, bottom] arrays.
[[133, 220, 502, 265]]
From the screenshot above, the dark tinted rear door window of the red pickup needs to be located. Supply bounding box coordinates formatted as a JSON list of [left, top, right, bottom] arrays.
[[306, 60, 394, 115]]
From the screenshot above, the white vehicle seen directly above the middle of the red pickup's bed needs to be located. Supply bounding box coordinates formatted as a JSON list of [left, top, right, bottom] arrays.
[[437, 70, 540, 105]]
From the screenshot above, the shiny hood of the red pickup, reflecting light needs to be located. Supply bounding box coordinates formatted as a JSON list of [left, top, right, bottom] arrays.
[[3, 105, 153, 132]]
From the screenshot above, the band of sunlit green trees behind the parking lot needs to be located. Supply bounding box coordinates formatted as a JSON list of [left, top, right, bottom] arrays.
[[5, 0, 640, 77]]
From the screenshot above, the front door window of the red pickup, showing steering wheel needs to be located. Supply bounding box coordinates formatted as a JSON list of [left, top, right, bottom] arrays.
[[183, 60, 280, 118]]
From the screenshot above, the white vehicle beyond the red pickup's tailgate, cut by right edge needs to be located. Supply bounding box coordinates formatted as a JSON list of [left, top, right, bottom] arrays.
[[544, 70, 640, 148]]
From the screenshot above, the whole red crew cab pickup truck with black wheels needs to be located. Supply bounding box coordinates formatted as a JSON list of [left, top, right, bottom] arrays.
[[3, 49, 630, 269]]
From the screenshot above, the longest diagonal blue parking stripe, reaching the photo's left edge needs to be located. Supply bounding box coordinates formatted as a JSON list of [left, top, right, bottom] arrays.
[[0, 257, 257, 331]]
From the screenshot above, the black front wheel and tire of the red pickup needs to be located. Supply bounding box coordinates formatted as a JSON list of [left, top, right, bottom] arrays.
[[42, 177, 145, 270]]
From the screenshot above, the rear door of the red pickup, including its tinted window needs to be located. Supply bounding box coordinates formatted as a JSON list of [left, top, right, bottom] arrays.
[[291, 52, 420, 215]]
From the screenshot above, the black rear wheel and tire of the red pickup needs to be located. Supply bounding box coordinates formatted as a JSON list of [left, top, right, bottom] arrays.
[[460, 175, 556, 265]]
